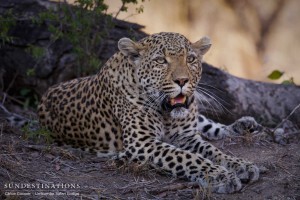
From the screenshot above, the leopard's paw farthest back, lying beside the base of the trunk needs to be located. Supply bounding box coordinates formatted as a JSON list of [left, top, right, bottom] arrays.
[[227, 116, 262, 135]]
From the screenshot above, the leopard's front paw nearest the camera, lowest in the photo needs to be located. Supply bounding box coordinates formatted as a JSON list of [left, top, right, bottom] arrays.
[[209, 166, 242, 194]]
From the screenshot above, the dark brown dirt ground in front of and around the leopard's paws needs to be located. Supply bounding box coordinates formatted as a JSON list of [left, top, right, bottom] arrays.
[[0, 116, 300, 200]]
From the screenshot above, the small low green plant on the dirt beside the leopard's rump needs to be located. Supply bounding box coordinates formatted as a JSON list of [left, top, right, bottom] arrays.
[[22, 121, 53, 144]]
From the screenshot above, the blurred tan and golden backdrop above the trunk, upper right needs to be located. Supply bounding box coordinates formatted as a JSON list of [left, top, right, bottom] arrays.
[[102, 0, 300, 84]]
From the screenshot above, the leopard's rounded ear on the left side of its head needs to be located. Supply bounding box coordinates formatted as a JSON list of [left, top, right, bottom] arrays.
[[118, 38, 140, 57]]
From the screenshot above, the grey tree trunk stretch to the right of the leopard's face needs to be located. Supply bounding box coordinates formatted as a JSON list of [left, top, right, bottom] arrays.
[[199, 63, 300, 126]]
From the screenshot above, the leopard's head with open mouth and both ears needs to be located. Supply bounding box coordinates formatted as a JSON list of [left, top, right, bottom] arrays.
[[118, 33, 211, 118]]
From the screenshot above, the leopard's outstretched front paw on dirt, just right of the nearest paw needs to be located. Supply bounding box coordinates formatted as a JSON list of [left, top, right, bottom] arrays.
[[236, 163, 259, 183]]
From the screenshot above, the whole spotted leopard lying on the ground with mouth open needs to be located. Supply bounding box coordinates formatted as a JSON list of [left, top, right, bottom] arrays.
[[38, 32, 259, 193]]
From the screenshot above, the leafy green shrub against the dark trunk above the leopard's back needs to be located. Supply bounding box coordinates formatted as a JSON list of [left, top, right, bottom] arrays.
[[32, 0, 143, 76]]
